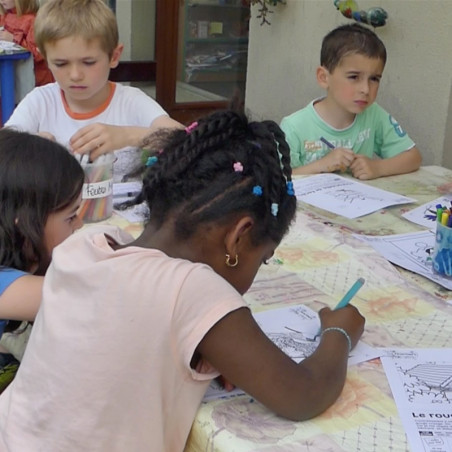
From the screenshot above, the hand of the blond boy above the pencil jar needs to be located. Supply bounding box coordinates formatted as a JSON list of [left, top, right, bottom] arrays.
[[69, 123, 133, 160]]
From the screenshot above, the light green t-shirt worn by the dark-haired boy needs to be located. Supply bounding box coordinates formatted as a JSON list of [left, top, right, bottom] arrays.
[[281, 99, 414, 168]]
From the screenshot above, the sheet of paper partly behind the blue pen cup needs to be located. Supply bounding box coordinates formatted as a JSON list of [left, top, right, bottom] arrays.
[[354, 230, 452, 290]]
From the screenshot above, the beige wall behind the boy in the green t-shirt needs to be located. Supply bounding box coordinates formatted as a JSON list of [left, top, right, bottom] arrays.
[[245, 0, 452, 168]]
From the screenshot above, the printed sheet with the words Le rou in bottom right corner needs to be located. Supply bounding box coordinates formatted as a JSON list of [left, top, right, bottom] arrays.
[[381, 348, 452, 452]]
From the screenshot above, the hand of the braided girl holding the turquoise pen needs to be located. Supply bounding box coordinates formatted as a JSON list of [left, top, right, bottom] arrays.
[[319, 304, 365, 347]]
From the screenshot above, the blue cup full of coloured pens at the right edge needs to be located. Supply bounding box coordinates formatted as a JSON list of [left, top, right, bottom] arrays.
[[432, 205, 452, 277]]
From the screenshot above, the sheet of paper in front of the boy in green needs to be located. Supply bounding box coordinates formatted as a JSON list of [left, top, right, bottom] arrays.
[[294, 173, 416, 218]]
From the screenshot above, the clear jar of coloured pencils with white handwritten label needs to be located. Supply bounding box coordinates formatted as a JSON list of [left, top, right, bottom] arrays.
[[79, 154, 115, 223]]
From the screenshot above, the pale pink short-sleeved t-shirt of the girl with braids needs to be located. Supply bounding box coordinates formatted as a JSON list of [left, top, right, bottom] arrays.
[[0, 226, 245, 452]]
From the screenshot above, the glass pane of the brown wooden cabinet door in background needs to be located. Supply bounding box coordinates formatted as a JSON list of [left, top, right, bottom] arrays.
[[176, 0, 250, 103]]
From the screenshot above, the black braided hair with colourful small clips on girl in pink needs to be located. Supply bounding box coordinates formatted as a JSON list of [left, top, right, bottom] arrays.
[[136, 111, 296, 244]]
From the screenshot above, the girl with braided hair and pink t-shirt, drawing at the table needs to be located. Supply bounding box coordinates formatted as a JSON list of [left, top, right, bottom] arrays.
[[0, 111, 364, 452]]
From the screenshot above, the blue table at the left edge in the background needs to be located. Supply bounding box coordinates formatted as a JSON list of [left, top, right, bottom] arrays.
[[0, 50, 31, 125]]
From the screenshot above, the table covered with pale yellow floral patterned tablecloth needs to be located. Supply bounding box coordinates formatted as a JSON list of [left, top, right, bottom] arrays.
[[162, 166, 452, 452]]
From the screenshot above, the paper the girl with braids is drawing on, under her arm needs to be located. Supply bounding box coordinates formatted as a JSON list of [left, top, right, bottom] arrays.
[[204, 305, 381, 401]]
